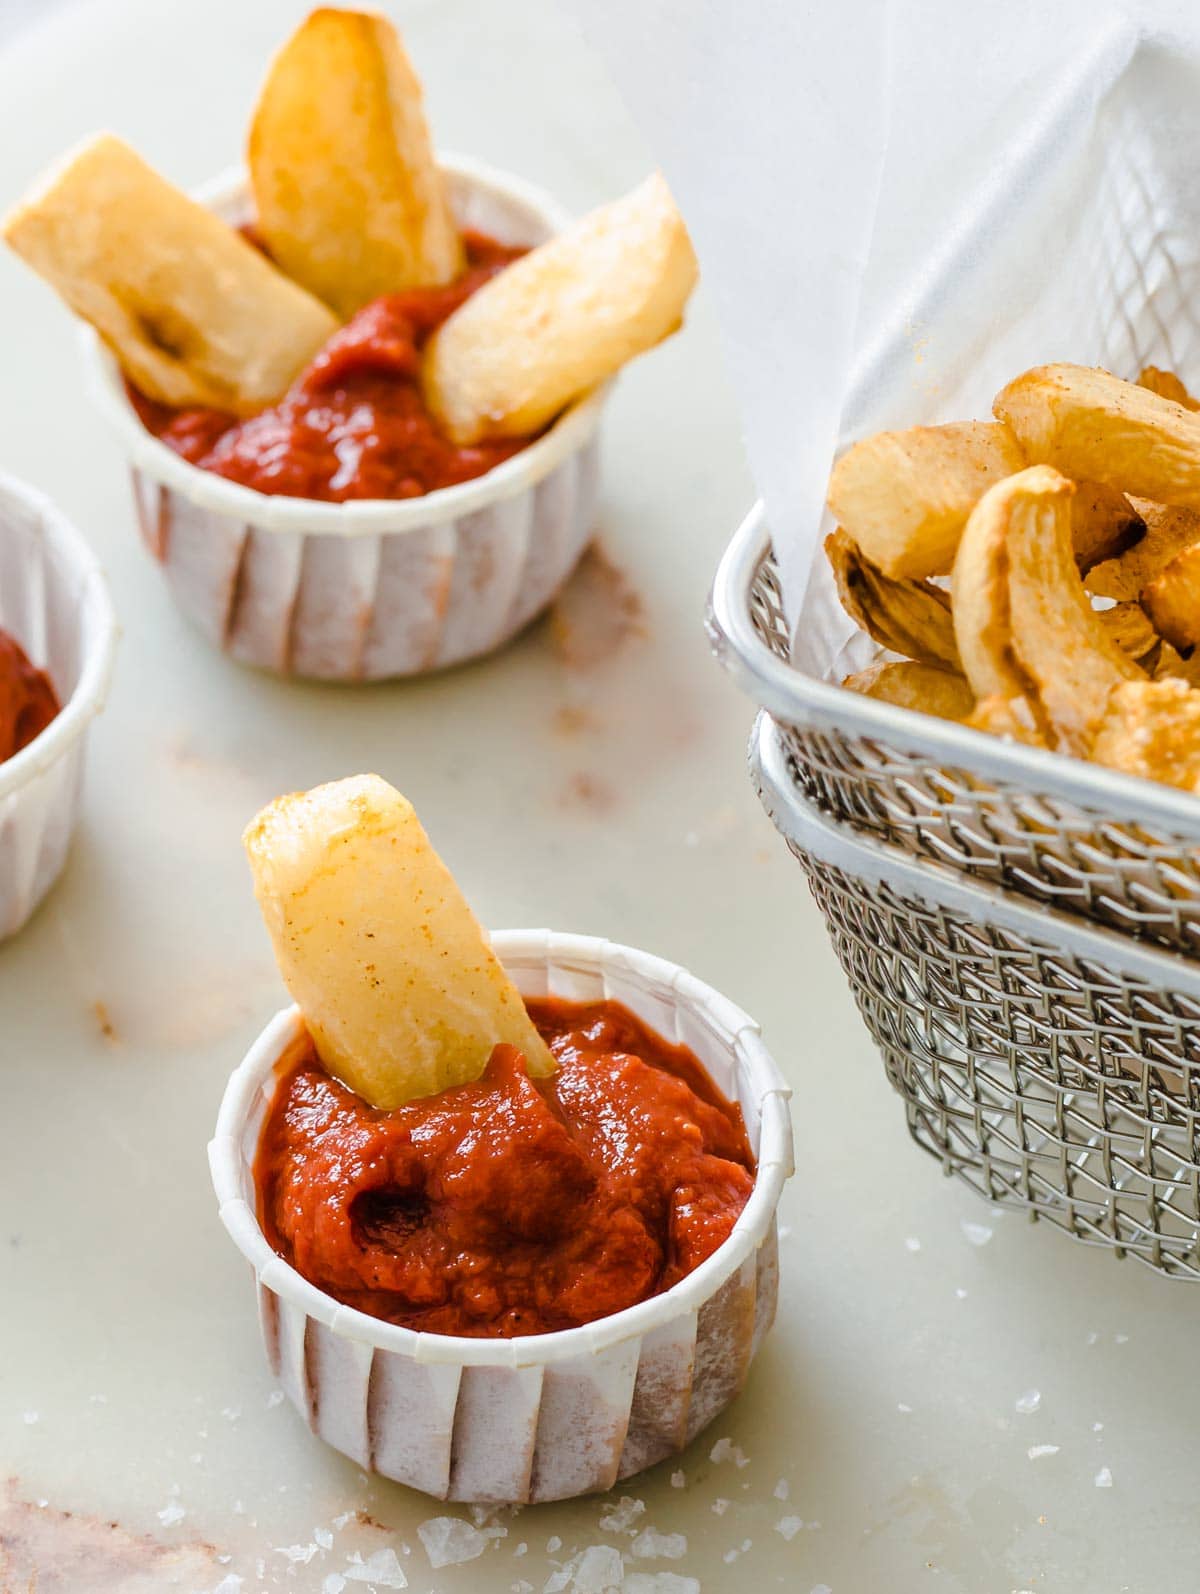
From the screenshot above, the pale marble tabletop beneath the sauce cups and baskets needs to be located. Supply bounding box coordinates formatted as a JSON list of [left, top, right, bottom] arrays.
[[0, 0, 1200, 1594]]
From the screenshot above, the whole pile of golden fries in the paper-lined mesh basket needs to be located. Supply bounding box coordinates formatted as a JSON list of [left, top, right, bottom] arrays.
[[825, 365, 1200, 792]]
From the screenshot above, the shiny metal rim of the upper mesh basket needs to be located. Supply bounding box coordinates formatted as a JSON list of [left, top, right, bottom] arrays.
[[706, 499, 1200, 843]]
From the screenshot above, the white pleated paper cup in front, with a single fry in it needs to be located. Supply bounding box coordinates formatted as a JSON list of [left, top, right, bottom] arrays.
[[209, 929, 792, 1503]]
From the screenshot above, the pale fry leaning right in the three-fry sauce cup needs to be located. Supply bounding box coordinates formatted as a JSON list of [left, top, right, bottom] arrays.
[[422, 172, 696, 443]]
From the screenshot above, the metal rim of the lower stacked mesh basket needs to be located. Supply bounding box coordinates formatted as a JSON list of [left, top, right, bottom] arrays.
[[749, 713, 1200, 999]]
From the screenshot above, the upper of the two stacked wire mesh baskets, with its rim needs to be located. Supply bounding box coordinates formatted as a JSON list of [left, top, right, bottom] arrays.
[[709, 510, 1200, 952]]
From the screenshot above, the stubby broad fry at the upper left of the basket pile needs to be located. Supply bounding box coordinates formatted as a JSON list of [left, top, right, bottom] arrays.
[[829, 421, 1025, 580]]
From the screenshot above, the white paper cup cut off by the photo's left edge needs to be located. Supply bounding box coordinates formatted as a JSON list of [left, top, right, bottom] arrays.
[[0, 475, 116, 937]]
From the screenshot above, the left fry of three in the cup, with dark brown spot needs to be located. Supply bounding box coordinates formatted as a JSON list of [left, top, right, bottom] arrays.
[[3, 134, 338, 414]]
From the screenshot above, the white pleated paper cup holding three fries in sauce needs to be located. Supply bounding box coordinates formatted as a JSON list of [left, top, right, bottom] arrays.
[[84, 156, 607, 681]]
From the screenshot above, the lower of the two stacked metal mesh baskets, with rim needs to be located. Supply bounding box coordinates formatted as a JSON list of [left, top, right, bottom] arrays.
[[751, 714, 1200, 1278]]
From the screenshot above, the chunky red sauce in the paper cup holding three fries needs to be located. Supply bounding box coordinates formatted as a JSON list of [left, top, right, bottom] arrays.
[[127, 233, 529, 504]]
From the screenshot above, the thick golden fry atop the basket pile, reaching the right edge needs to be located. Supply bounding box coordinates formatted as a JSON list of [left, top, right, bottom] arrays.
[[993, 365, 1200, 508]]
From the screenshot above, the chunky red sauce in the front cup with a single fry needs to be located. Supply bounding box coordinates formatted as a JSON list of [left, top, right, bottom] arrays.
[[255, 999, 754, 1339]]
